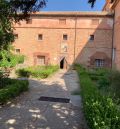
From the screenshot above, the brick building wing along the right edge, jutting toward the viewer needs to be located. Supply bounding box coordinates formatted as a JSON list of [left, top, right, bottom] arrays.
[[103, 0, 120, 70]]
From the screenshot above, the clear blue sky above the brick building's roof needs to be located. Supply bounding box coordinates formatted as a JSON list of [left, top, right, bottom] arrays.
[[42, 0, 105, 11]]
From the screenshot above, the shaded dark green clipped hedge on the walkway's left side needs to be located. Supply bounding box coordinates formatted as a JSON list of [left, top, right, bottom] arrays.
[[0, 79, 29, 104]]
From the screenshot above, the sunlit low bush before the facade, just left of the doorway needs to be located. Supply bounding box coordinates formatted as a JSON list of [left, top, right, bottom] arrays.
[[16, 66, 59, 78]]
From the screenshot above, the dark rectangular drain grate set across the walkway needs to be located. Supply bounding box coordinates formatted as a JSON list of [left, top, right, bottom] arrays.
[[39, 96, 70, 103]]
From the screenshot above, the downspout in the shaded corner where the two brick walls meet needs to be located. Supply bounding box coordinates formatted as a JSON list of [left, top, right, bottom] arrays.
[[111, 10, 115, 68]]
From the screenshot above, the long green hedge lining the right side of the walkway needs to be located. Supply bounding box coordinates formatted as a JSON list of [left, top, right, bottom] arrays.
[[75, 65, 120, 129]]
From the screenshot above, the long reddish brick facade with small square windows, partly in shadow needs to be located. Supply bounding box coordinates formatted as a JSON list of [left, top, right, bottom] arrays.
[[13, 12, 113, 67]]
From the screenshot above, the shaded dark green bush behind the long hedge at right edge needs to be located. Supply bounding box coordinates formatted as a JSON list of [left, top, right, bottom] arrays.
[[92, 69, 120, 98]]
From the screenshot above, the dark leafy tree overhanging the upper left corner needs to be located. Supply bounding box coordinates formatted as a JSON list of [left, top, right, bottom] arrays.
[[0, 0, 46, 50]]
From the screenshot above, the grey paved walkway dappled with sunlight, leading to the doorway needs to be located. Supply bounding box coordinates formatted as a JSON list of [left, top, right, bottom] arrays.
[[0, 70, 85, 129]]
